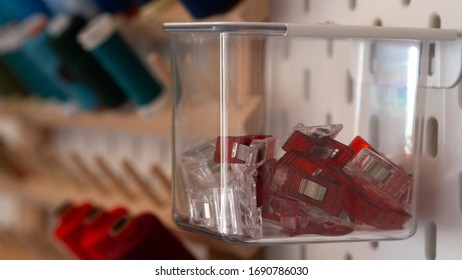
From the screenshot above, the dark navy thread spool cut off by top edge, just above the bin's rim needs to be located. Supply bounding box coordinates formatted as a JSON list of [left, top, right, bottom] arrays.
[[182, 0, 240, 18]]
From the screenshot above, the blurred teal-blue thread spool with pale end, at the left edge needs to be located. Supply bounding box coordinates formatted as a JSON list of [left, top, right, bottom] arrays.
[[0, 22, 65, 99]]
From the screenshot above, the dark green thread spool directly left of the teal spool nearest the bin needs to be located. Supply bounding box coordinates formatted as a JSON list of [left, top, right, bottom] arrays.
[[48, 15, 127, 108]]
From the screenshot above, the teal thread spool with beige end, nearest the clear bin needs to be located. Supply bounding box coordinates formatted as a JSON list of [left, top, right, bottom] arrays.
[[78, 14, 163, 107]]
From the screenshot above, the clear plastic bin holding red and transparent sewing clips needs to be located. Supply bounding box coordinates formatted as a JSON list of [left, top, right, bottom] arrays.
[[164, 23, 462, 244]]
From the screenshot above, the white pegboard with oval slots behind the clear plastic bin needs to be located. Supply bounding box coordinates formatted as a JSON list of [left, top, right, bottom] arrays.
[[267, 0, 462, 259]]
